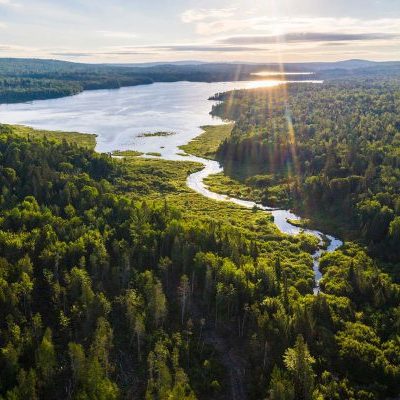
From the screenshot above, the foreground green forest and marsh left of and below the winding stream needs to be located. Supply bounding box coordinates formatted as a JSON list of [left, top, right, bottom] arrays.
[[0, 122, 400, 400]]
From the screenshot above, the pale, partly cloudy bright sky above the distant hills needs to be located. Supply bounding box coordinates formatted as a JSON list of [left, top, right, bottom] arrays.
[[0, 0, 400, 63]]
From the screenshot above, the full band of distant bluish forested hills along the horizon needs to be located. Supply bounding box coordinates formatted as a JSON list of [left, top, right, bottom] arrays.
[[0, 58, 400, 103]]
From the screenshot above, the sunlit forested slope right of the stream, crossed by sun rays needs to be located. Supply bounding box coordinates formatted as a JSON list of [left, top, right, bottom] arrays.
[[213, 77, 400, 263]]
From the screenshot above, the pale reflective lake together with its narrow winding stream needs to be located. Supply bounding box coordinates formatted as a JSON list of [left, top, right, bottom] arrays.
[[0, 80, 343, 293]]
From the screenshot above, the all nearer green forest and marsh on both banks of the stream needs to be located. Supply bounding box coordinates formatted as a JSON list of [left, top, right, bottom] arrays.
[[0, 57, 400, 400]]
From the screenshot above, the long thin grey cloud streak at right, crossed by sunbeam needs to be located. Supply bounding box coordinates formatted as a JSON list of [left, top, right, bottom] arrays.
[[220, 32, 399, 45]]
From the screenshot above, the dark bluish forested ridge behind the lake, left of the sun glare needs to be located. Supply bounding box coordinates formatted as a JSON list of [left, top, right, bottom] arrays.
[[0, 59, 256, 103]]
